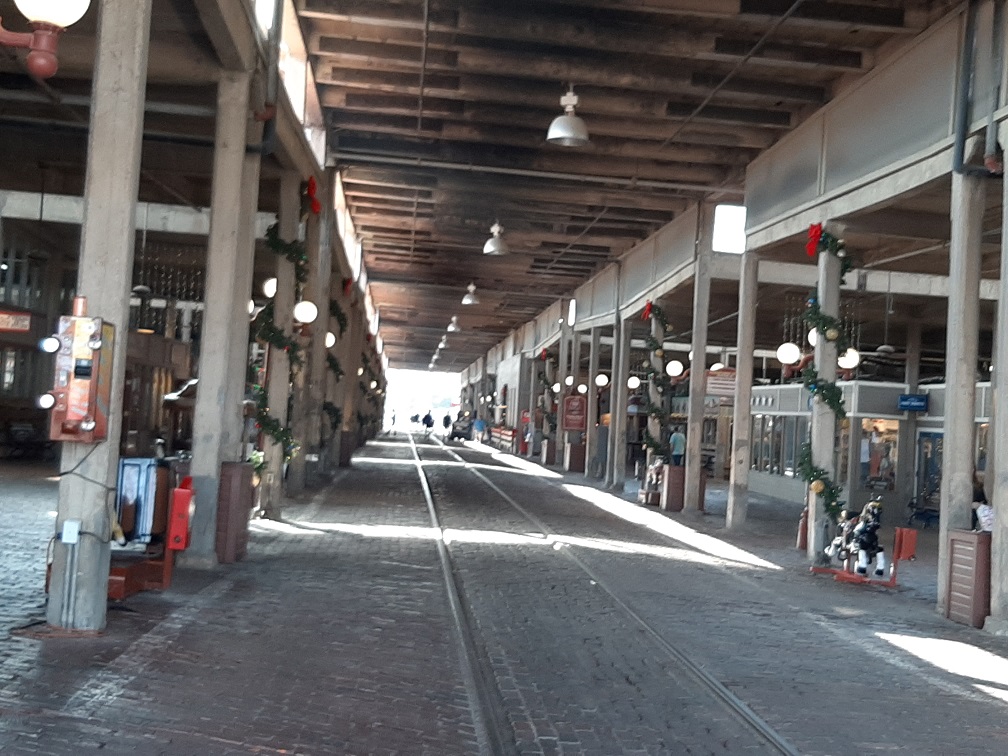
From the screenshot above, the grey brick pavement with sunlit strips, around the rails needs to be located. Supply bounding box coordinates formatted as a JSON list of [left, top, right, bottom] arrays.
[[0, 437, 1008, 755]]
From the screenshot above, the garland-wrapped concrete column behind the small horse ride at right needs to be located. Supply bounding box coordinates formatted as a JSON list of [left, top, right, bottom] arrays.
[[806, 245, 840, 561]]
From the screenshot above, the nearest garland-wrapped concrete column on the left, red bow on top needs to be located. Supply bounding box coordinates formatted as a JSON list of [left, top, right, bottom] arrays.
[[261, 171, 300, 520]]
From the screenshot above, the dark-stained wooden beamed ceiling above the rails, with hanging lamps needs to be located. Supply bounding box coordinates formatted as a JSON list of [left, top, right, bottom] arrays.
[[297, 0, 956, 370]]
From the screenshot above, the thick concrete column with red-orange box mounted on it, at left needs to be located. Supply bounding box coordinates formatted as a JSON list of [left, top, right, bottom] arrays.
[[45, 0, 151, 630]]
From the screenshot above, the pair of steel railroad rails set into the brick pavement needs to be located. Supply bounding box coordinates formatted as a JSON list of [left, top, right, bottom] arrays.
[[401, 434, 799, 756]]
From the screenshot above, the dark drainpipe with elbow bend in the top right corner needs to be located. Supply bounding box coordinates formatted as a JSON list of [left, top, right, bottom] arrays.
[[953, 0, 1004, 178]]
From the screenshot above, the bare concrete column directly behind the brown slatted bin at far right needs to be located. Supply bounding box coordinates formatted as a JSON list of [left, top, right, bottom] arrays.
[[937, 173, 983, 612]]
